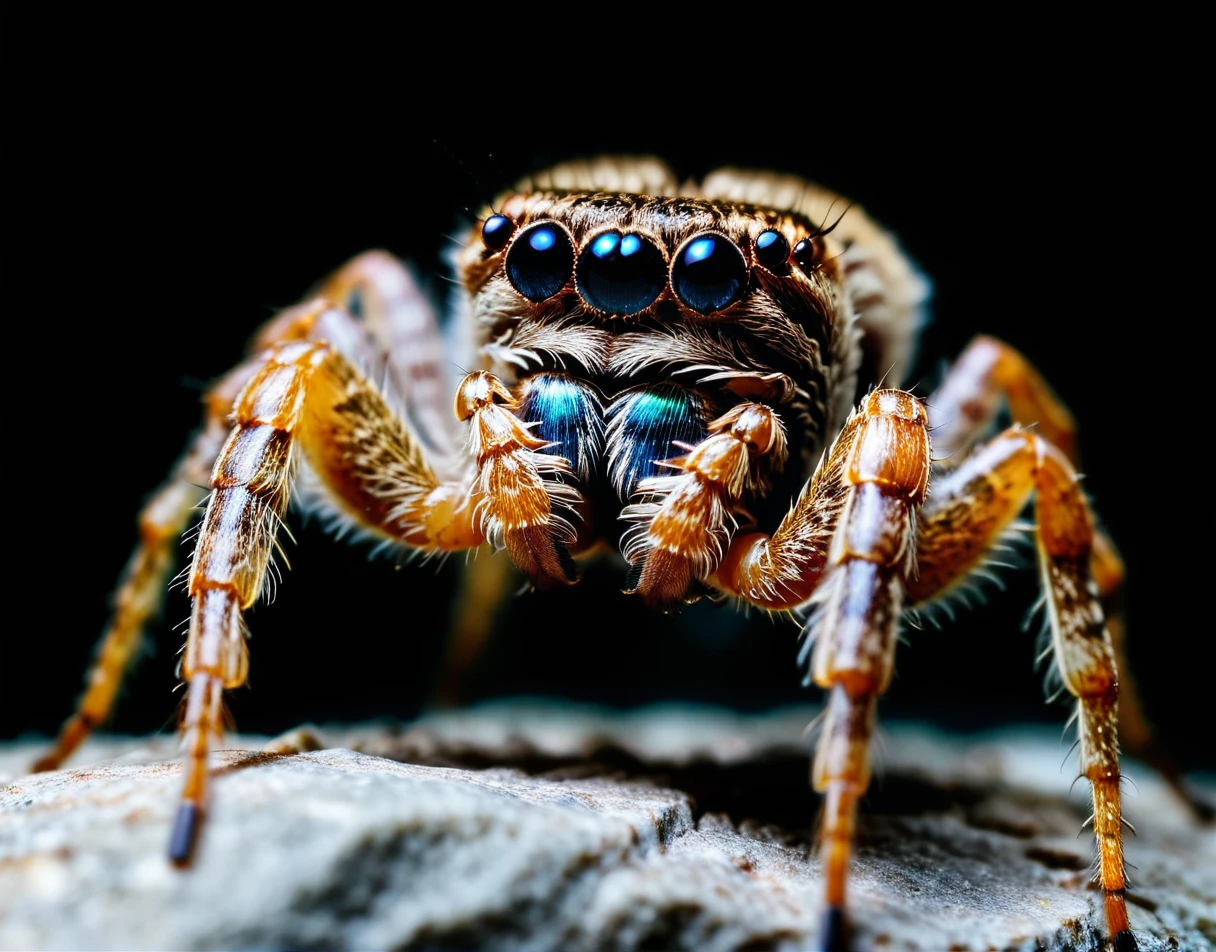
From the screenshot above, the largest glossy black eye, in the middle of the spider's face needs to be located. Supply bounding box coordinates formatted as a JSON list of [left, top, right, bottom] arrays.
[[574, 231, 668, 315]]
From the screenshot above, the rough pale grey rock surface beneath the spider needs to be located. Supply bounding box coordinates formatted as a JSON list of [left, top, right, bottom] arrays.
[[0, 705, 1216, 952]]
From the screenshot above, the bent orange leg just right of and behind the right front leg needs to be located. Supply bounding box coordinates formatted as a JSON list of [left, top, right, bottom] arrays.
[[907, 427, 1137, 952]]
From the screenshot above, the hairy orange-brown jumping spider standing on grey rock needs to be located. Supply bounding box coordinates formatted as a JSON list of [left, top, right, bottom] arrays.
[[38, 158, 1137, 952]]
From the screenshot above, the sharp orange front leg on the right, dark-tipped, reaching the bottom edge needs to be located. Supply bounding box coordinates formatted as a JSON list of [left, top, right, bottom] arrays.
[[709, 390, 931, 952]]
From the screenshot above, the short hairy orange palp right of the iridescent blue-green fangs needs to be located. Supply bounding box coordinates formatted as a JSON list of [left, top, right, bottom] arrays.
[[621, 404, 787, 607]]
